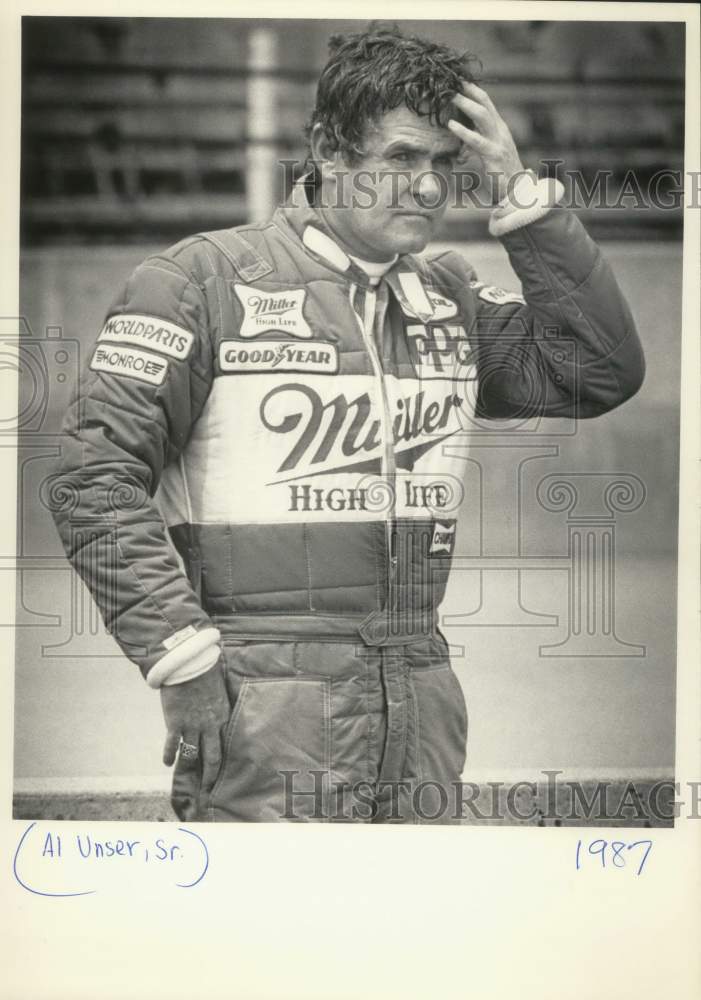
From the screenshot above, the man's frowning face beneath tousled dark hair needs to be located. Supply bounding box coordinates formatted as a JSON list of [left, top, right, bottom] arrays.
[[322, 106, 460, 261]]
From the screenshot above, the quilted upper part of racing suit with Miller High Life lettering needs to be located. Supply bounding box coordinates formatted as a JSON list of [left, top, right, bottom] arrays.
[[54, 180, 643, 686]]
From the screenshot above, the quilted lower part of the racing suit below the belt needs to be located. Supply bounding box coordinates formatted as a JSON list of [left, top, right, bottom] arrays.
[[172, 635, 467, 823]]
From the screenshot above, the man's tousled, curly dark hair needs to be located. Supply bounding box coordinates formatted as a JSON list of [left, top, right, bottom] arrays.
[[305, 25, 479, 164]]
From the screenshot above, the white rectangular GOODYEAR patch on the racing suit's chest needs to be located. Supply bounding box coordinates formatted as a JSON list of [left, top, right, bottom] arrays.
[[219, 340, 338, 375]]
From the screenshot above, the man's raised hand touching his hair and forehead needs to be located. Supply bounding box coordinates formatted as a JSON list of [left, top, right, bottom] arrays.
[[448, 83, 524, 201]]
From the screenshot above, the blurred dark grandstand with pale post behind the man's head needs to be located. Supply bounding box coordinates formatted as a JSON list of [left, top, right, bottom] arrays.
[[22, 17, 684, 246]]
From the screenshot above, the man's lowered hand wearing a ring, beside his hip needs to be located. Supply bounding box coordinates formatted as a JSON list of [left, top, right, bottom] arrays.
[[160, 660, 230, 791]]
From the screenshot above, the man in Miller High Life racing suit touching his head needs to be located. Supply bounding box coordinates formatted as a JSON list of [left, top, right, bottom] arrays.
[[50, 30, 643, 821]]
